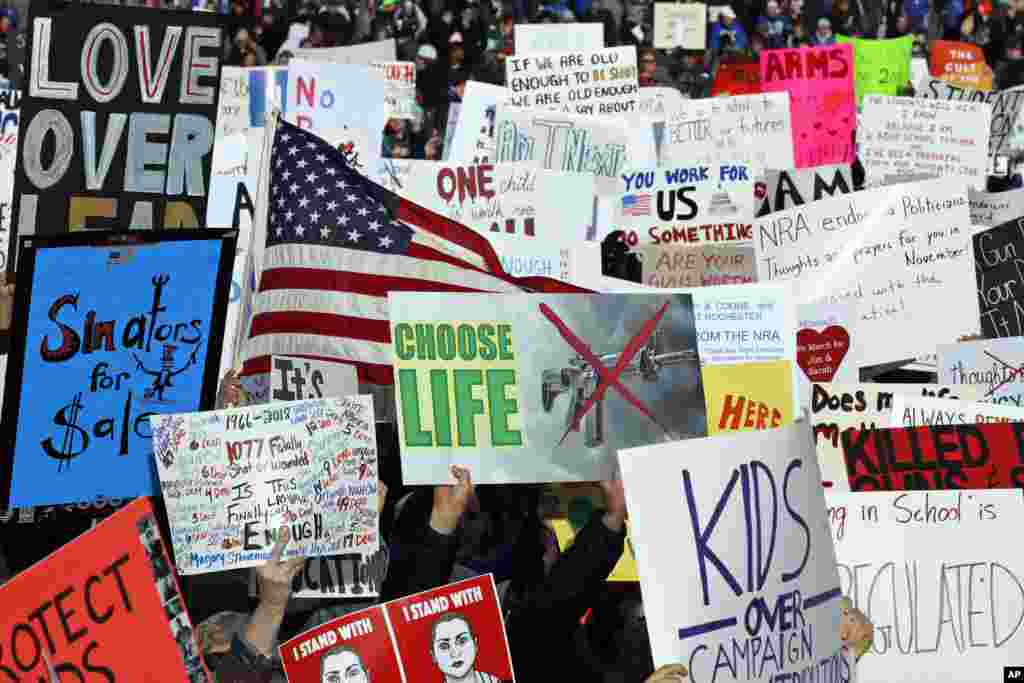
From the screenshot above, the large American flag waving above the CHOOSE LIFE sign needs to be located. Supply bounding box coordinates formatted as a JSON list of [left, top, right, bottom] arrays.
[[242, 121, 587, 385]]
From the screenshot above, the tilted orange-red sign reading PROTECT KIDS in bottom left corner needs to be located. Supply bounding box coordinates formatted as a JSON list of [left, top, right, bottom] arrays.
[[0, 499, 213, 682]]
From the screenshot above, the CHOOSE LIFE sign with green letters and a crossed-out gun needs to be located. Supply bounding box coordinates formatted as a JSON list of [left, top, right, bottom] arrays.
[[388, 293, 706, 484]]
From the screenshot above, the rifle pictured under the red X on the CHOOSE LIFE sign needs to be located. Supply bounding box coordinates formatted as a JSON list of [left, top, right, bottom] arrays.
[[541, 332, 698, 449]]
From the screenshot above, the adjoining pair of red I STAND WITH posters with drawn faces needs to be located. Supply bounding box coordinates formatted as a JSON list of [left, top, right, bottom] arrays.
[[279, 574, 514, 683]]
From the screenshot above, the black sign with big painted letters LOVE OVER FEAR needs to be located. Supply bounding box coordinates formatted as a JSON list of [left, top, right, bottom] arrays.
[[13, 2, 221, 266]]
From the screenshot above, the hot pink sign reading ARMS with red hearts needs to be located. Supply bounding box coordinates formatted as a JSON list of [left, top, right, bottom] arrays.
[[761, 45, 857, 168]]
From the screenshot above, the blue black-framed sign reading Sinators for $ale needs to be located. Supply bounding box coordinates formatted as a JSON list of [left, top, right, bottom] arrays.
[[0, 229, 236, 507]]
